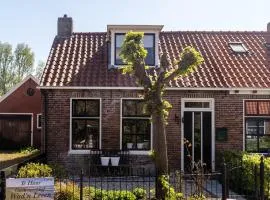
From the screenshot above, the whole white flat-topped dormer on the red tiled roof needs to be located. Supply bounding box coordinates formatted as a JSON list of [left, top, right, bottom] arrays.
[[107, 25, 163, 68]]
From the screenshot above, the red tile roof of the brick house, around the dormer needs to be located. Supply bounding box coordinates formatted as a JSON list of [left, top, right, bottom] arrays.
[[41, 31, 270, 88]]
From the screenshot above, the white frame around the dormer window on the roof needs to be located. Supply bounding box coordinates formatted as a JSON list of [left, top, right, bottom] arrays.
[[111, 29, 159, 68]]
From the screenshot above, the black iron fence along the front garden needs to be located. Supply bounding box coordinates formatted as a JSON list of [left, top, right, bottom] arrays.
[[0, 159, 270, 200]]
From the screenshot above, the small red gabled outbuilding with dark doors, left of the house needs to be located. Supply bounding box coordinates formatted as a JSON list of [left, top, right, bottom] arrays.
[[0, 75, 42, 149]]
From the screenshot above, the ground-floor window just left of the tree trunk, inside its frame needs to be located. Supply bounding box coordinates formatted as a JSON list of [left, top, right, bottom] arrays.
[[122, 99, 151, 150]]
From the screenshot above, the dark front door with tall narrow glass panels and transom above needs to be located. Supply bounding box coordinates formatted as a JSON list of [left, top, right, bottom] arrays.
[[182, 100, 214, 171]]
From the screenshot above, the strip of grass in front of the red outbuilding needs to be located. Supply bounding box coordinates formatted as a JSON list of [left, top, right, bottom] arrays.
[[0, 148, 39, 170]]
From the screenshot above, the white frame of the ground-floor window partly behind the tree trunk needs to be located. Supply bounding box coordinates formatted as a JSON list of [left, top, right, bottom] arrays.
[[120, 98, 153, 155]]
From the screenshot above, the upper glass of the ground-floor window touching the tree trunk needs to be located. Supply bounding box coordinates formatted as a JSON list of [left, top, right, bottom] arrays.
[[123, 100, 150, 117]]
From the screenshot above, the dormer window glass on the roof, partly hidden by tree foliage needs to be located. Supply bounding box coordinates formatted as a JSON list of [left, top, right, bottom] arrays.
[[115, 33, 155, 66]]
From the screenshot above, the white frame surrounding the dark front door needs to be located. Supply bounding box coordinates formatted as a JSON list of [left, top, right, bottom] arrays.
[[181, 98, 216, 171]]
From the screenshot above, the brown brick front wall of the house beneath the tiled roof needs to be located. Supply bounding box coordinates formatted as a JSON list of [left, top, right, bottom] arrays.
[[42, 90, 270, 172]]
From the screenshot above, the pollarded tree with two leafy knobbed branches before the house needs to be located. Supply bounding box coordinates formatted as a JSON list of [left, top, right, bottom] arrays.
[[120, 31, 203, 199]]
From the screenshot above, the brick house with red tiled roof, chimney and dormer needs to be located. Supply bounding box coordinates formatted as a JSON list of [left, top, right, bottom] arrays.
[[40, 15, 270, 170]]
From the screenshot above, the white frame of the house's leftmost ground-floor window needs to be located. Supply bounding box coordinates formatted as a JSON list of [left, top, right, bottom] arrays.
[[68, 97, 102, 154]]
